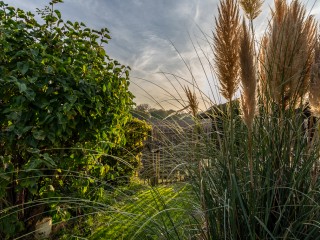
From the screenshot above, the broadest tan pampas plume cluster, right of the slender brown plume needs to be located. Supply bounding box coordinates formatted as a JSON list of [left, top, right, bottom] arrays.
[[261, 0, 316, 107]]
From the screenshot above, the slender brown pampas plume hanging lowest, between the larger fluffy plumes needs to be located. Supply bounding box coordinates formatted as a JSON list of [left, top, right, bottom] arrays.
[[239, 21, 257, 129]]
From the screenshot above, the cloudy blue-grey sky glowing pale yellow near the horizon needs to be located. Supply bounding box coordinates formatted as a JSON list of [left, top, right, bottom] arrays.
[[4, 0, 320, 110]]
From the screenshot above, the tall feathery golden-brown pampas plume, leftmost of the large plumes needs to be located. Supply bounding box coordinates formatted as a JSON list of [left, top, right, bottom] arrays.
[[213, 0, 240, 102]]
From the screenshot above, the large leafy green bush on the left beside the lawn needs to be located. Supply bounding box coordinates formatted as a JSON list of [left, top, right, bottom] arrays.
[[0, 1, 133, 238]]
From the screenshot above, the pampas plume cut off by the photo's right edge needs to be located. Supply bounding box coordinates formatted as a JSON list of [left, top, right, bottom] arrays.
[[309, 41, 320, 117]]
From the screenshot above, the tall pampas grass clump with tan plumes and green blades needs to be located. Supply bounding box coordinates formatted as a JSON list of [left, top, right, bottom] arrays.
[[188, 0, 320, 239]]
